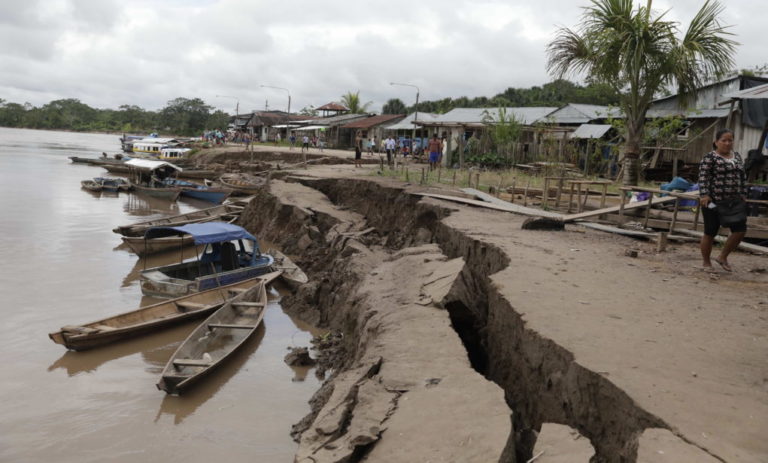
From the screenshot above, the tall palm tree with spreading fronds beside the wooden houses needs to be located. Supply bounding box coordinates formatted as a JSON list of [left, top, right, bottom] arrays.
[[547, 0, 738, 185]]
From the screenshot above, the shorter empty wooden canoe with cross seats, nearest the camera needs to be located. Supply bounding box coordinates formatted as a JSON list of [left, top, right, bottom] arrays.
[[157, 284, 267, 395]]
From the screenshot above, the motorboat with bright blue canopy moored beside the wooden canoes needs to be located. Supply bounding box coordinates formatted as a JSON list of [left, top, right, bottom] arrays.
[[140, 222, 274, 297]]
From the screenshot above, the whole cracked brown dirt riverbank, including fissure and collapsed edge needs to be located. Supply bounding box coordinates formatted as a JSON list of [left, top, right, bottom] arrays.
[[202, 150, 768, 463]]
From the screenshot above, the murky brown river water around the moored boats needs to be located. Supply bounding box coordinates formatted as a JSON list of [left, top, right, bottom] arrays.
[[0, 128, 319, 463]]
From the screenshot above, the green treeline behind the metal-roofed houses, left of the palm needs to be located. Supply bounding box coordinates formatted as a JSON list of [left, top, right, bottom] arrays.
[[383, 79, 619, 114]]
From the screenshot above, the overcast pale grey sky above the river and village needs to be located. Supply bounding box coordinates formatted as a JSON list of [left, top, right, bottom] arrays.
[[0, 0, 768, 113]]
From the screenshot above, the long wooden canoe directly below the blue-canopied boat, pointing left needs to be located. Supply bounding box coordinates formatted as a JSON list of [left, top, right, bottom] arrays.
[[48, 272, 280, 350]]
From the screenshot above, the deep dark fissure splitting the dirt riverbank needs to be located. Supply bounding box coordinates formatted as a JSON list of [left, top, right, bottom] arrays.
[[240, 178, 684, 462]]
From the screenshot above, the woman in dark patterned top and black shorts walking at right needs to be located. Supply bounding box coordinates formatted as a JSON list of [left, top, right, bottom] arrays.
[[699, 129, 747, 272]]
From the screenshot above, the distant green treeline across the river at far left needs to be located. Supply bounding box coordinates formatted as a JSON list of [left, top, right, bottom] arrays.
[[0, 98, 229, 136]]
